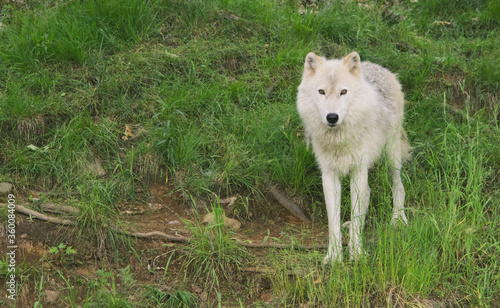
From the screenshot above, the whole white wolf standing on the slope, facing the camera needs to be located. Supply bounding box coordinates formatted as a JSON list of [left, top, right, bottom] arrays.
[[297, 52, 409, 263]]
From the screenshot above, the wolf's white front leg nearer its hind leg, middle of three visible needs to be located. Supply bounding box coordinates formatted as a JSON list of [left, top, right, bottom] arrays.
[[349, 167, 370, 260]]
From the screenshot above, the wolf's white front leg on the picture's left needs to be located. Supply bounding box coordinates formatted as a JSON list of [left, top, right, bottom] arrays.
[[322, 171, 342, 264]]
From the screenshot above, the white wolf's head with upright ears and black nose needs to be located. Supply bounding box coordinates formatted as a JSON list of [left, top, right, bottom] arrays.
[[299, 52, 362, 127]]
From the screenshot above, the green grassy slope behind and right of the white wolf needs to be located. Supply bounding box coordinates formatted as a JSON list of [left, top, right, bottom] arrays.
[[0, 0, 500, 306]]
